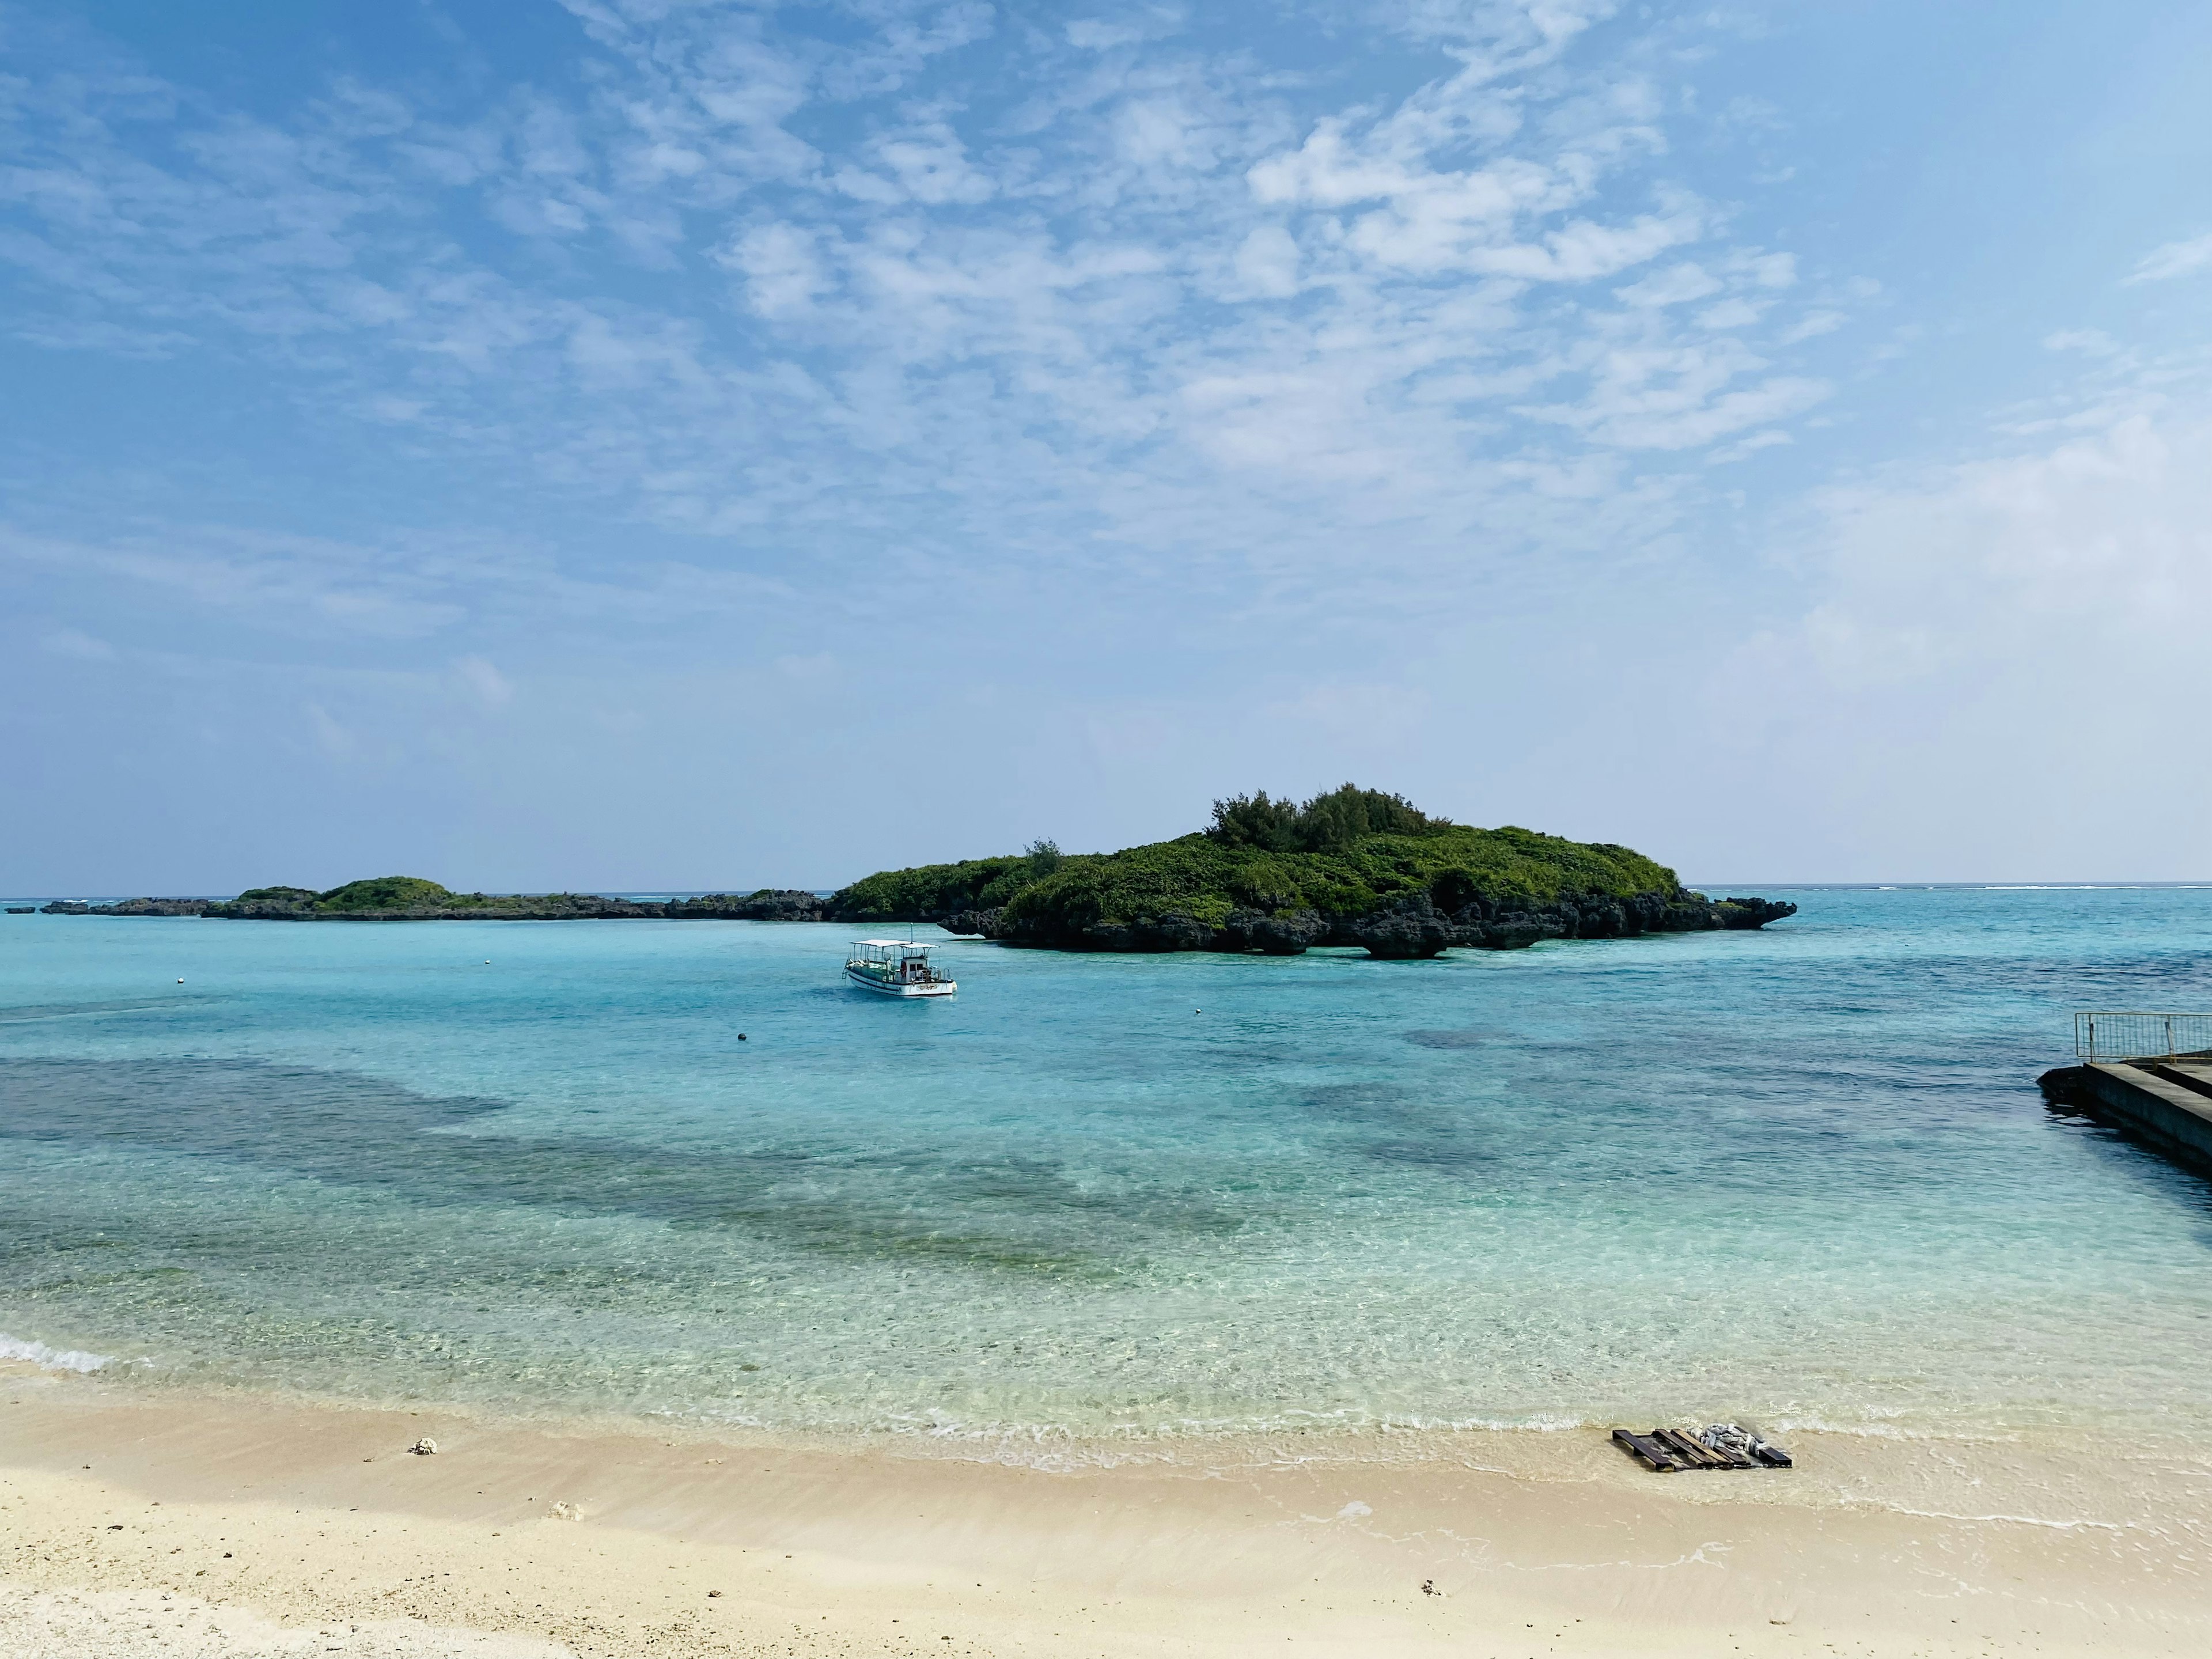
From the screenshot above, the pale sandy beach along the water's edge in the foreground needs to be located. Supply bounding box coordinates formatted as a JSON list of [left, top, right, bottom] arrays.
[[0, 1367, 2212, 1659]]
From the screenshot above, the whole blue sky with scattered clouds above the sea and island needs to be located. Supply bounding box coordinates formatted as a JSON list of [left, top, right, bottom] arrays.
[[0, 0, 2212, 893]]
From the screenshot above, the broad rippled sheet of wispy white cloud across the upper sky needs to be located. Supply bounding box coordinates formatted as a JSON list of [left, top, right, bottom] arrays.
[[0, 0, 1838, 630]]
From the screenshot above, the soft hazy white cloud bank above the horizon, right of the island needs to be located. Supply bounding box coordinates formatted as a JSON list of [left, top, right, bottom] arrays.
[[1706, 394, 2212, 880]]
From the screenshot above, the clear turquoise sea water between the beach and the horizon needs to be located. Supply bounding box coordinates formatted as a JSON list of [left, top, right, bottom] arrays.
[[0, 889, 2212, 1438]]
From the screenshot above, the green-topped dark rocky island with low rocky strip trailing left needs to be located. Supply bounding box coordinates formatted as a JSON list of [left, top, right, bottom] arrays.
[[47, 783, 1796, 960]]
